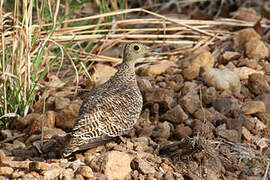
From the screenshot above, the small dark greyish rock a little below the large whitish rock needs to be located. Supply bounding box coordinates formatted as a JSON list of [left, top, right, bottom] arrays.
[[212, 98, 232, 114]]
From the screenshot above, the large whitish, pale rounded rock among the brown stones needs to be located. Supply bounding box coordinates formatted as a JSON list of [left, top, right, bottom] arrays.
[[201, 67, 241, 94]]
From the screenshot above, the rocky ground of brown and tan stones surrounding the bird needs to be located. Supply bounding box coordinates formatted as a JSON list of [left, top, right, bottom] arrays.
[[0, 1, 270, 180]]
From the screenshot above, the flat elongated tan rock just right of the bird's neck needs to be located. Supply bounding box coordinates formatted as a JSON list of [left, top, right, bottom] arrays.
[[139, 60, 176, 77]]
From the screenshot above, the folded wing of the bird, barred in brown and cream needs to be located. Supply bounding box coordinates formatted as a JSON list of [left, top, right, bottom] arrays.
[[73, 87, 141, 140]]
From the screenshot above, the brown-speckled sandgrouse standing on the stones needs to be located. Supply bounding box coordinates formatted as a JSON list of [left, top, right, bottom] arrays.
[[63, 43, 147, 157]]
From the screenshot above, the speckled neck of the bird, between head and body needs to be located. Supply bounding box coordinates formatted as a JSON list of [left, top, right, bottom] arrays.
[[115, 62, 136, 82]]
